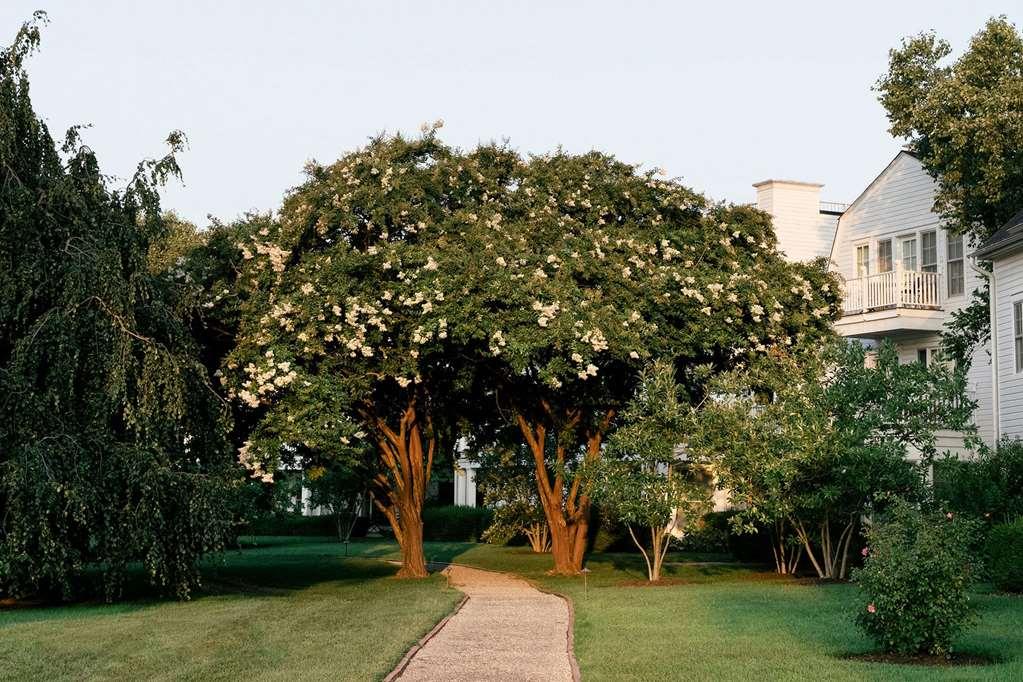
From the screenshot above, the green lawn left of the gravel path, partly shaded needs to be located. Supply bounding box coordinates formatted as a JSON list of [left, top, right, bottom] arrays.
[[0, 538, 461, 680]]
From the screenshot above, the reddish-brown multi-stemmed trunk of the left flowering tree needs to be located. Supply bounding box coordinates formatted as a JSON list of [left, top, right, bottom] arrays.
[[370, 400, 437, 578]]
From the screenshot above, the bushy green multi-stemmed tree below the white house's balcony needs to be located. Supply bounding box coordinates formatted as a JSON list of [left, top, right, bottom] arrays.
[[688, 340, 973, 579]]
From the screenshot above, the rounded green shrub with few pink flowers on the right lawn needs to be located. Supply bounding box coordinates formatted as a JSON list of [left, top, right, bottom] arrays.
[[853, 502, 977, 655]]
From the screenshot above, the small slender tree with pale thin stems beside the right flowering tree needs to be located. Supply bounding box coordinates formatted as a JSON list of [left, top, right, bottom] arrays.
[[588, 361, 714, 582]]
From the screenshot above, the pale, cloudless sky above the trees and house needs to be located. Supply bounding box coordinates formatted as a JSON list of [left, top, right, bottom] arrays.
[[0, 0, 1023, 226]]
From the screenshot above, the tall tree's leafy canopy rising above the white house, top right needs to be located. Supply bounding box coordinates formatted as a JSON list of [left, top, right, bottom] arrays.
[[876, 16, 1023, 364]]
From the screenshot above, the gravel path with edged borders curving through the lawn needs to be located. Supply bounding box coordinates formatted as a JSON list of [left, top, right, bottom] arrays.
[[390, 565, 574, 682]]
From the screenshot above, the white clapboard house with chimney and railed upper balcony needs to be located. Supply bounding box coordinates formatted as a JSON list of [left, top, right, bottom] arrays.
[[754, 151, 994, 452]]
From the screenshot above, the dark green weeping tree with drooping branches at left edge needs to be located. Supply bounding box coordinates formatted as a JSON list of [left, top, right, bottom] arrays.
[[0, 13, 234, 598]]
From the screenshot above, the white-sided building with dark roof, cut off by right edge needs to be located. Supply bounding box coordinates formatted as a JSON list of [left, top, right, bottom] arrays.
[[973, 211, 1023, 438]]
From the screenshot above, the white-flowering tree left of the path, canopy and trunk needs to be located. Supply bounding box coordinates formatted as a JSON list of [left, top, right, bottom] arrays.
[[224, 126, 510, 577]]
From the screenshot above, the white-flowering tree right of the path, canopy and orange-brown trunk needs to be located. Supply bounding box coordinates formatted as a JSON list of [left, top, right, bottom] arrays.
[[449, 152, 838, 574]]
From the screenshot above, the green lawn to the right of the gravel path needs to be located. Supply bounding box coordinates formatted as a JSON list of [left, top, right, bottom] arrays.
[[331, 543, 1023, 682]]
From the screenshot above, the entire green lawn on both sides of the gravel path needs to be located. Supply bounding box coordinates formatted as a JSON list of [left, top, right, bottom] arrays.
[[0, 538, 1023, 682]]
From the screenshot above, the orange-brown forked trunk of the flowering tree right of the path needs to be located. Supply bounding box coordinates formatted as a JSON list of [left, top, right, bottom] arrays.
[[516, 406, 614, 576]]
